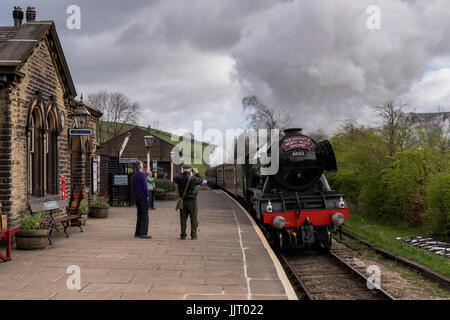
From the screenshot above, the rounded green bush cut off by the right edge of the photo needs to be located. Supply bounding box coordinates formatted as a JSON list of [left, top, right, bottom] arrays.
[[426, 172, 450, 241]]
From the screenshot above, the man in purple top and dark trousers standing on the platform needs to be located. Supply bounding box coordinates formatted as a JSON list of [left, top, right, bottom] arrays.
[[133, 161, 151, 239]]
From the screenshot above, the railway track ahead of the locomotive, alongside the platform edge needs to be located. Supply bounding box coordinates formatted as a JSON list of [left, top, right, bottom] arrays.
[[280, 250, 394, 300]]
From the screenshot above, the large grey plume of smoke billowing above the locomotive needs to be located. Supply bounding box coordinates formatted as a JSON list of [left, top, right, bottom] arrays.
[[232, 0, 450, 133]]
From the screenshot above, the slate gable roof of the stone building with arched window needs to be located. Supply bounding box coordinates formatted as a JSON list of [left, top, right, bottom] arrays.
[[0, 21, 77, 97]]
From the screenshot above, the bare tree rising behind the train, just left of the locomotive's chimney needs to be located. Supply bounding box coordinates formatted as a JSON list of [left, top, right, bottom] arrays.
[[242, 95, 290, 130]]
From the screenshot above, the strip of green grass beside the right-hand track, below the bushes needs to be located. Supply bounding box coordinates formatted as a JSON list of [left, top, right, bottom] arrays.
[[344, 211, 450, 277]]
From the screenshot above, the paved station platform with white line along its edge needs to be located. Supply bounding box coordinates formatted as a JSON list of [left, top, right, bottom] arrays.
[[0, 190, 296, 300]]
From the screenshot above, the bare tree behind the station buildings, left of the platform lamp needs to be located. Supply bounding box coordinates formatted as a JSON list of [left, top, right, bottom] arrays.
[[87, 90, 140, 141]]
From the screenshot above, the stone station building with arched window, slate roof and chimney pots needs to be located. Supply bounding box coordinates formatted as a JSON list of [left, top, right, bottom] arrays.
[[0, 7, 102, 227]]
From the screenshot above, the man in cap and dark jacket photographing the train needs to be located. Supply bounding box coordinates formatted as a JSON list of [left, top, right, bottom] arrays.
[[173, 164, 203, 240]]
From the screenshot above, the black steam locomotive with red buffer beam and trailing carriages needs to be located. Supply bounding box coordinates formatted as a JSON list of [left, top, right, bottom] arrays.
[[206, 129, 349, 249]]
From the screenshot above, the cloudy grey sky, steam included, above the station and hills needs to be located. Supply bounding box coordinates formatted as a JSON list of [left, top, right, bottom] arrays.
[[0, 0, 450, 142]]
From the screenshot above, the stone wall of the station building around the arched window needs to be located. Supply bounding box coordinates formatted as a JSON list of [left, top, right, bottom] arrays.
[[0, 39, 103, 227]]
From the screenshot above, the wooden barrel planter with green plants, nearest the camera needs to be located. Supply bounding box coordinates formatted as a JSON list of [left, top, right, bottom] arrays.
[[16, 212, 50, 250]]
